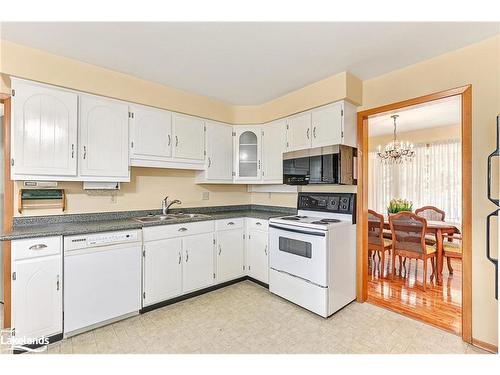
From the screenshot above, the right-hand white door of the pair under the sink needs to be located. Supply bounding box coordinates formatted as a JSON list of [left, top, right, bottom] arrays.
[[182, 233, 214, 293]]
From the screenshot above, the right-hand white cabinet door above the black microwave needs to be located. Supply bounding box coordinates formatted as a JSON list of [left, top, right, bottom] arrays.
[[311, 102, 342, 147]]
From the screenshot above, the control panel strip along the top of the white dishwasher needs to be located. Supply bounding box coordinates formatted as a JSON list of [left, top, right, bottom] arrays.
[[64, 230, 142, 251]]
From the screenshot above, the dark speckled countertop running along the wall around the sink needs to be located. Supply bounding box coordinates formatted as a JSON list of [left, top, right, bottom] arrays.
[[0, 205, 296, 241]]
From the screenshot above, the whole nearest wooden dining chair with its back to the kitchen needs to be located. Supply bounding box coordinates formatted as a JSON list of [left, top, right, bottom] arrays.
[[389, 211, 436, 291]]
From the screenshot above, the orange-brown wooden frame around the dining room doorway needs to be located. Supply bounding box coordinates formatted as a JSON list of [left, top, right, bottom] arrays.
[[356, 85, 472, 343]]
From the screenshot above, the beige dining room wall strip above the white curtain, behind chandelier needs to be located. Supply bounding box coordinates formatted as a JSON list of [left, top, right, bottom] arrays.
[[368, 121, 461, 151]]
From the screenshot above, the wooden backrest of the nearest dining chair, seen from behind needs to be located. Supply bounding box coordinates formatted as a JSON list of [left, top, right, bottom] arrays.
[[389, 211, 427, 254]]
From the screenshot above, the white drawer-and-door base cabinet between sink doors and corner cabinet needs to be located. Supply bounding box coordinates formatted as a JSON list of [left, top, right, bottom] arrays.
[[215, 218, 245, 282]]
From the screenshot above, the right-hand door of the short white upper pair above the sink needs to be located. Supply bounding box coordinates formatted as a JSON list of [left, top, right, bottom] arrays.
[[172, 113, 205, 162]]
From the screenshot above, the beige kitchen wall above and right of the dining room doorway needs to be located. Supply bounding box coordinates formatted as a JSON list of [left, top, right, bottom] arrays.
[[361, 36, 500, 345]]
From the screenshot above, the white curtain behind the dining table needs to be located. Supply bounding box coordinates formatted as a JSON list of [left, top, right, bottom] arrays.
[[368, 139, 462, 223]]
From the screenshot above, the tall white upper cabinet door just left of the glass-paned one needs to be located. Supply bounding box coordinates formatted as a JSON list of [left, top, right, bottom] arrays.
[[205, 121, 233, 181]]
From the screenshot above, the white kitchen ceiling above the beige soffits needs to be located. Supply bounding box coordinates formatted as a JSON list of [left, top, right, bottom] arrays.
[[0, 22, 500, 105]]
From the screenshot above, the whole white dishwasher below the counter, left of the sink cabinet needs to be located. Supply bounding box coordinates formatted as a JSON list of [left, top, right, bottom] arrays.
[[64, 230, 142, 337]]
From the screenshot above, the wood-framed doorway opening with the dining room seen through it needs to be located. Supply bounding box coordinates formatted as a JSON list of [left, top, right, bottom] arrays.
[[358, 88, 470, 341]]
